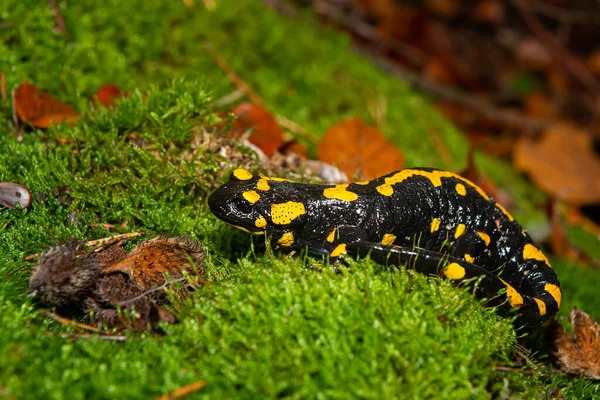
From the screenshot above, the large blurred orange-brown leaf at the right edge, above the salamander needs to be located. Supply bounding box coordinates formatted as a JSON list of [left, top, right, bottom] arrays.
[[513, 123, 600, 204]]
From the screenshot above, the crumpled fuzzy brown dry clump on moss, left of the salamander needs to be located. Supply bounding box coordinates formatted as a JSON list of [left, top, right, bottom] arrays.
[[29, 237, 204, 331]]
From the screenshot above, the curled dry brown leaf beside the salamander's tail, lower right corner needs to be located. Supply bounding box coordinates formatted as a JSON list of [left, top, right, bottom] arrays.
[[554, 307, 600, 379]]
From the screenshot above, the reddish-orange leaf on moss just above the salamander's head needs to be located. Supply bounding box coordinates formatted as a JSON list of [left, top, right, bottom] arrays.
[[230, 103, 284, 157]]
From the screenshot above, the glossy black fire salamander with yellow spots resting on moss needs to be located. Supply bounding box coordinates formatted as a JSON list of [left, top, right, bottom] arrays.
[[208, 168, 561, 326]]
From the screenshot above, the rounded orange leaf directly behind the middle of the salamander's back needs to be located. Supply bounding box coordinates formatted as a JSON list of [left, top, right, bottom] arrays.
[[317, 117, 404, 179]]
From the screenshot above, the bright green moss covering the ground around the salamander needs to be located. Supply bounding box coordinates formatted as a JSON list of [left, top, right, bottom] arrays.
[[0, 0, 600, 399]]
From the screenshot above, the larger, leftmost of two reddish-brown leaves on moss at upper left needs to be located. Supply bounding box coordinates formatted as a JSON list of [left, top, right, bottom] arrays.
[[14, 82, 80, 128]]
